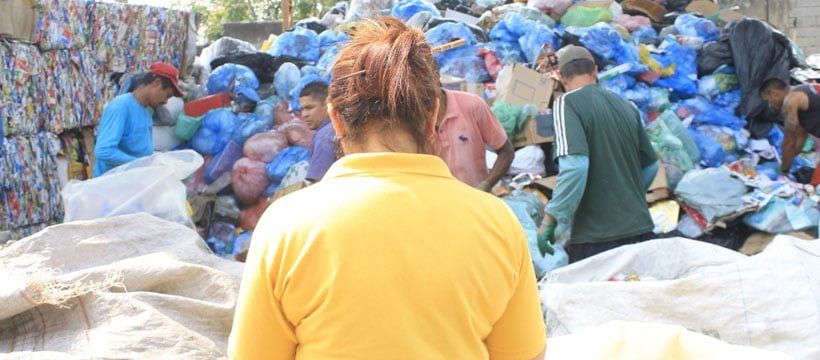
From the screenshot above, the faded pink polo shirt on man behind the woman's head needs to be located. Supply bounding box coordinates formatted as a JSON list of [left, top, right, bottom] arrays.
[[432, 90, 507, 186]]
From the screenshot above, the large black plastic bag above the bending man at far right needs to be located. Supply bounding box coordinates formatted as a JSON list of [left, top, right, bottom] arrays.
[[729, 18, 793, 116]]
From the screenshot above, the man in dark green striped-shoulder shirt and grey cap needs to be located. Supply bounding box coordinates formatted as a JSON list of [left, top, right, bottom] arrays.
[[539, 45, 658, 262]]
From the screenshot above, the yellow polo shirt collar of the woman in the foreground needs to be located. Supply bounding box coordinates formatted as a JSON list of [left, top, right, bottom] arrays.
[[324, 152, 454, 180]]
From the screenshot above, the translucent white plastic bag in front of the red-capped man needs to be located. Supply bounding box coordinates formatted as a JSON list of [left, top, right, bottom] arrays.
[[61, 150, 203, 226]]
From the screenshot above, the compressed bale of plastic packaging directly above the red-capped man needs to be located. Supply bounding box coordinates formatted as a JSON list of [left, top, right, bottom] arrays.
[[88, 2, 189, 72]]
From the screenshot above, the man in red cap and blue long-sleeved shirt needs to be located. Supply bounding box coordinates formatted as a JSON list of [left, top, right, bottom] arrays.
[[94, 62, 183, 177]]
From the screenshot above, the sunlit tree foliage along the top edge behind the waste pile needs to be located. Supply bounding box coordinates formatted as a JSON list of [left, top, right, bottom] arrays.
[[174, 0, 337, 42]]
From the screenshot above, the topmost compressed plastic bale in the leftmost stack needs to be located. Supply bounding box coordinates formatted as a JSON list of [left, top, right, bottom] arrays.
[[34, 0, 88, 50]]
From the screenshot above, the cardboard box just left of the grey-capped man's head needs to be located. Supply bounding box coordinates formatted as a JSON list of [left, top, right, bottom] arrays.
[[495, 64, 555, 112]]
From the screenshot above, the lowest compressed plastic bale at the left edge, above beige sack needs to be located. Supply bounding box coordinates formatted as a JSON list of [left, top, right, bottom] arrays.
[[0, 132, 63, 235]]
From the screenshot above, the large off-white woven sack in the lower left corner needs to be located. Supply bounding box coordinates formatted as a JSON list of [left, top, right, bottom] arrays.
[[0, 214, 242, 359]]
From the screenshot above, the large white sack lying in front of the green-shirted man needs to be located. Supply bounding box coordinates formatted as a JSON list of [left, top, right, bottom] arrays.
[[540, 236, 820, 359]]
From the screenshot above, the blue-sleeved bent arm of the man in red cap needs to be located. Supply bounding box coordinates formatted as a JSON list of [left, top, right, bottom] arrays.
[[94, 104, 137, 168]]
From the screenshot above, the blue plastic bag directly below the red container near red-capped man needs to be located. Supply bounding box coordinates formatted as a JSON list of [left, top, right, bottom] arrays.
[[191, 109, 239, 155]]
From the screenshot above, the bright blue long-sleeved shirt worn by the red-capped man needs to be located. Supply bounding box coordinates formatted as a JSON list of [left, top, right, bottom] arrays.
[[94, 93, 154, 177]]
